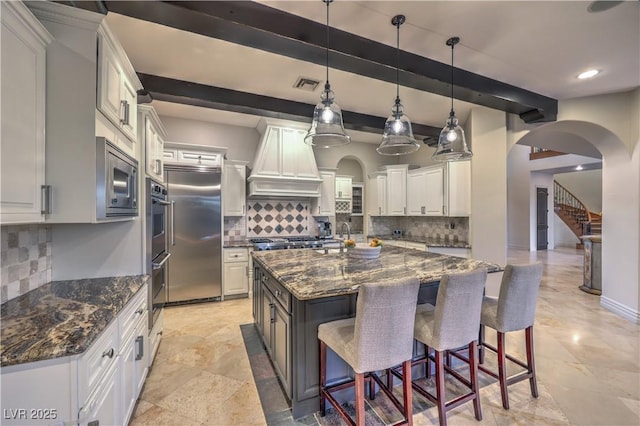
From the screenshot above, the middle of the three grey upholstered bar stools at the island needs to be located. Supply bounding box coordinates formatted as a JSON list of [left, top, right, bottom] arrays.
[[413, 269, 487, 425]]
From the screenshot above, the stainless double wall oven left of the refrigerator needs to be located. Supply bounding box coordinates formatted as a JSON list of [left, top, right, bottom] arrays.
[[146, 178, 171, 332]]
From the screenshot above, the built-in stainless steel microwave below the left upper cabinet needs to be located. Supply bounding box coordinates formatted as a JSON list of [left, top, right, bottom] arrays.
[[96, 137, 138, 219]]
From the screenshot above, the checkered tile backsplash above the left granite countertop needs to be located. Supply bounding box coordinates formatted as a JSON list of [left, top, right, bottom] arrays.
[[0, 224, 51, 303]]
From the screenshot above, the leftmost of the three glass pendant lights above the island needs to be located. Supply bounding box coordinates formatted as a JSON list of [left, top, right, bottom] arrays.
[[304, 0, 351, 148]]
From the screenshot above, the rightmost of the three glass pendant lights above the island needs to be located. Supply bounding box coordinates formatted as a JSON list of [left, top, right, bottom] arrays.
[[431, 37, 473, 161]]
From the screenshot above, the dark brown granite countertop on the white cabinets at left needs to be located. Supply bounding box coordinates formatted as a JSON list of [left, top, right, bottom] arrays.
[[0, 275, 149, 367]]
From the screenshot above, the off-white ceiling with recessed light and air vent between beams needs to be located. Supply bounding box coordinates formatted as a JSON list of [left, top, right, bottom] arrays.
[[102, 0, 640, 142]]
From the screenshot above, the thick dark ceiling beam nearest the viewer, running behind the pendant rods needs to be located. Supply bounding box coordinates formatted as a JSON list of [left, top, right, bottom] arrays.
[[99, 1, 558, 122]]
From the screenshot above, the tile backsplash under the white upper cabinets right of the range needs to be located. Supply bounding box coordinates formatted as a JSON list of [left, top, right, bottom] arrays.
[[368, 216, 469, 242]]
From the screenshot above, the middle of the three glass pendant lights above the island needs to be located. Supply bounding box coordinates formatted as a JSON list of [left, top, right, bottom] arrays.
[[376, 15, 420, 155]]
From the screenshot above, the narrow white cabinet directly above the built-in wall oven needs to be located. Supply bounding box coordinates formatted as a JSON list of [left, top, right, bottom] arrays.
[[138, 105, 167, 182]]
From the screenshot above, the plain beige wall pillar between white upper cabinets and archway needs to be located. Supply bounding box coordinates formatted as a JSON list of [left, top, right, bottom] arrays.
[[466, 107, 507, 296]]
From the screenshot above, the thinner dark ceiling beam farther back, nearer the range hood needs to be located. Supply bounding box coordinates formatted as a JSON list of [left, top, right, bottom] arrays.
[[138, 73, 441, 139]]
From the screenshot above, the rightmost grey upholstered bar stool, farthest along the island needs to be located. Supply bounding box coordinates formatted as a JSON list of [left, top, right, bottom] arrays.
[[479, 262, 543, 410]]
